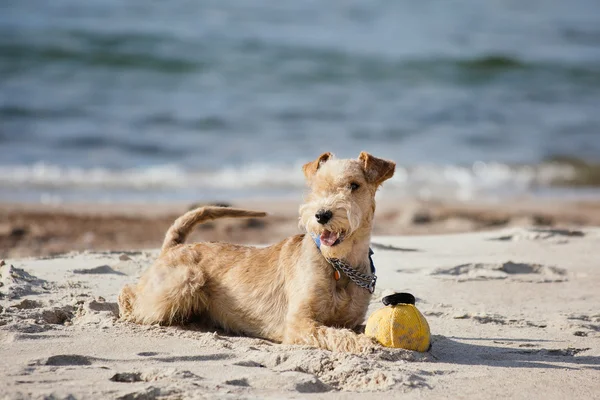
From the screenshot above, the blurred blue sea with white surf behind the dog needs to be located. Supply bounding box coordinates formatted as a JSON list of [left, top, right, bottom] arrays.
[[0, 0, 600, 202]]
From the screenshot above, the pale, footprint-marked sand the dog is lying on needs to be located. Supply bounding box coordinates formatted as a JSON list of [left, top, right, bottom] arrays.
[[0, 229, 600, 400]]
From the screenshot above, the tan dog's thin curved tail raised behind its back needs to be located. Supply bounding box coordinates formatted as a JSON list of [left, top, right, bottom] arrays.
[[162, 206, 267, 252]]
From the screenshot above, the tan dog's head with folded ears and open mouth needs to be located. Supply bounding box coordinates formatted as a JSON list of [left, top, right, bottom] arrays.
[[300, 152, 396, 255]]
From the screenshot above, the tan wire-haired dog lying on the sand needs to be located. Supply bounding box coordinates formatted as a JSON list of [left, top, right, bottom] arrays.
[[119, 152, 395, 353]]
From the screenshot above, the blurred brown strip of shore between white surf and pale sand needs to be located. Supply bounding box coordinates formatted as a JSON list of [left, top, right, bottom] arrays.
[[0, 198, 600, 258]]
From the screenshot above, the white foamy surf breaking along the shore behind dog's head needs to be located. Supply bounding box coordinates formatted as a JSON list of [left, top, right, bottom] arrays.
[[0, 162, 600, 200]]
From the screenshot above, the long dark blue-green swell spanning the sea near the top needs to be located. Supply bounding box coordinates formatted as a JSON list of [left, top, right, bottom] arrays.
[[0, 30, 600, 84]]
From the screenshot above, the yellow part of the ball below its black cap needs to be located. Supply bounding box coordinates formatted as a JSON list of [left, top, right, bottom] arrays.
[[365, 296, 431, 351]]
